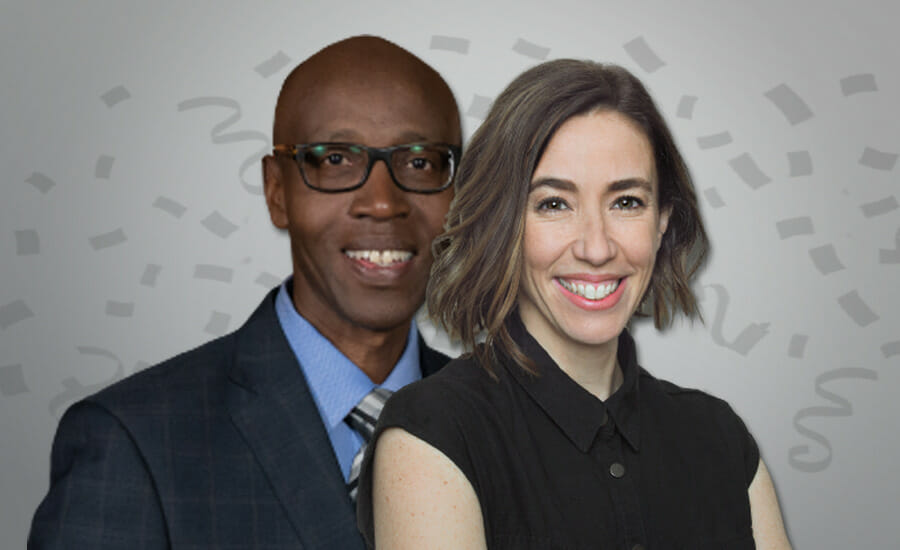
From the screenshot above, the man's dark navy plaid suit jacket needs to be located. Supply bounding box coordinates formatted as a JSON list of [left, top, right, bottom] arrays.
[[28, 291, 448, 550]]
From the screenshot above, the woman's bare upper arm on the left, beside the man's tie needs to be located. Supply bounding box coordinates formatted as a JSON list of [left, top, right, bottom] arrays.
[[372, 428, 487, 550]]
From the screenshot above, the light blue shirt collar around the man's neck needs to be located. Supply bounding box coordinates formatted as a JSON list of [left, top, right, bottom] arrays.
[[275, 278, 422, 429]]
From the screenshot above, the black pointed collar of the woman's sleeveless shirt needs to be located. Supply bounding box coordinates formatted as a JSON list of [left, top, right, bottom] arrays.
[[503, 313, 640, 453]]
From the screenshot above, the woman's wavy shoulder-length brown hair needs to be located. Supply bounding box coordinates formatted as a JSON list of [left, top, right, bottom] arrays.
[[427, 59, 709, 371]]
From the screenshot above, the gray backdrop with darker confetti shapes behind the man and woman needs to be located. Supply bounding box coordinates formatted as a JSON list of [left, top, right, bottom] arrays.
[[0, 0, 900, 549]]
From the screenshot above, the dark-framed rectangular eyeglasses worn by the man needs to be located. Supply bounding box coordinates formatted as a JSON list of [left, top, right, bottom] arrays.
[[273, 143, 462, 193]]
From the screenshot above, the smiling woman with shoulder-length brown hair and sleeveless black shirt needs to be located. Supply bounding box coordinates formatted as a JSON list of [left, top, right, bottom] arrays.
[[359, 60, 790, 549]]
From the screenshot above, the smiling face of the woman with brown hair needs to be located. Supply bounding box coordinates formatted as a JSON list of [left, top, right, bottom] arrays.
[[519, 111, 669, 355]]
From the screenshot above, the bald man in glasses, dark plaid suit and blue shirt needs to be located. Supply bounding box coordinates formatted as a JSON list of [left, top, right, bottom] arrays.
[[28, 37, 460, 549]]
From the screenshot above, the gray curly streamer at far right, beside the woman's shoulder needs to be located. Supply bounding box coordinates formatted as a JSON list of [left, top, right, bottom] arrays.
[[788, 367, 878, 472]]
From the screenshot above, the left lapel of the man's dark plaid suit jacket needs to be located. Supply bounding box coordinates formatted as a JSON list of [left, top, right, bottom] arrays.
[[227, 291, 364, 549]]
